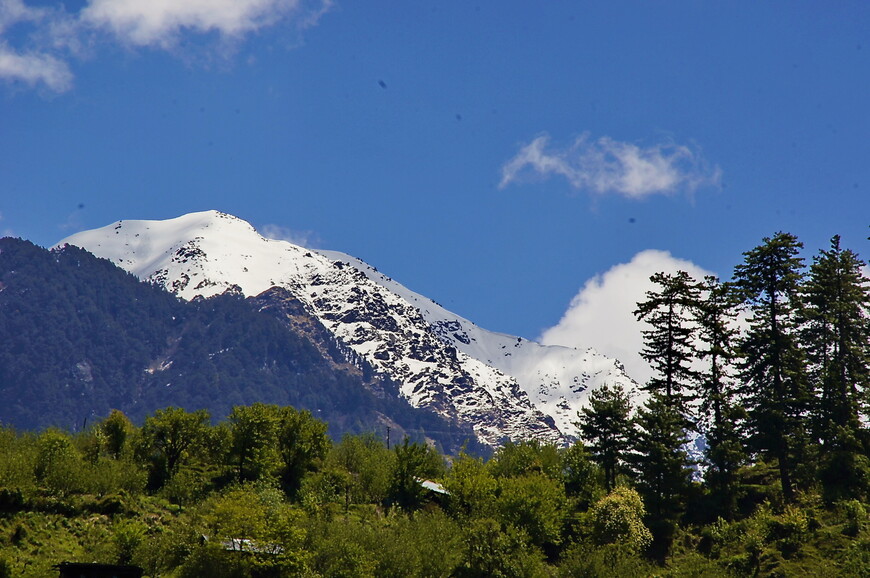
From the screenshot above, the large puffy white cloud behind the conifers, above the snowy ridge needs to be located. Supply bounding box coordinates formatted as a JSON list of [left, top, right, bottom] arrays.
[[539, 249, 712, 383]]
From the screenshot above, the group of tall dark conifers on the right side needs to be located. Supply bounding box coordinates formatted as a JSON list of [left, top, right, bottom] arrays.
[[578, 228, 870, 574]]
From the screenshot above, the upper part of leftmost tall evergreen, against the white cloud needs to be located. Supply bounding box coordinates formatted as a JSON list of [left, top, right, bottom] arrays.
[[634, 271, 700, 418]]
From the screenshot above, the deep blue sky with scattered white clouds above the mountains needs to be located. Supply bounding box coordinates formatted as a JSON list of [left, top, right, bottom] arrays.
[[0, 0, 870, 368]]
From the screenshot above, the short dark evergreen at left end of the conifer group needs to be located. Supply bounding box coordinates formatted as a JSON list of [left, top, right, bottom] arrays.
[[577, 385, 631, 492]]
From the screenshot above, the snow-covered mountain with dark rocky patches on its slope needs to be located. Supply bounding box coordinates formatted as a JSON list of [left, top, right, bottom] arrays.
[[58, 211, 634, 445]]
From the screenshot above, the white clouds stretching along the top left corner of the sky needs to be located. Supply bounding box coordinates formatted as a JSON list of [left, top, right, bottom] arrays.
[[0, 0, 332, 92]]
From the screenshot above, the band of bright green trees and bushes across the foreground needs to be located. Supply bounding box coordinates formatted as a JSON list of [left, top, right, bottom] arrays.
[[0, 404, 870, 578]]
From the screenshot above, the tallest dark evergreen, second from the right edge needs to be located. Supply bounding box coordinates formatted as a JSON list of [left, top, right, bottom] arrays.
[[734, 232, 808, 501]]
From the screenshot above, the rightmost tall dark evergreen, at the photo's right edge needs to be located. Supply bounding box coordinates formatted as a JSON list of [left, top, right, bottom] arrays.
[[802, 236, 870, 500]]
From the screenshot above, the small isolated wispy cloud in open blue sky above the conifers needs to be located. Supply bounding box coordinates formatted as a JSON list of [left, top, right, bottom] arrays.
[[499, 134, 722, 198]]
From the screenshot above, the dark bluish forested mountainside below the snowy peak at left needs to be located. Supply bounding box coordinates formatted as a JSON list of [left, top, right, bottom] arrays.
[[0, 238, 478, 451]]
